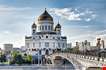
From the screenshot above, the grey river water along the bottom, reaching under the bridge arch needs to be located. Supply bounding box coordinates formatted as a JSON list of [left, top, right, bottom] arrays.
[[0, 59, 75, 70]]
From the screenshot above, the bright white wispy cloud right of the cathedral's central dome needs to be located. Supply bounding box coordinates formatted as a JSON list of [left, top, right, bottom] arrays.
[[49, 8, 96, 22]]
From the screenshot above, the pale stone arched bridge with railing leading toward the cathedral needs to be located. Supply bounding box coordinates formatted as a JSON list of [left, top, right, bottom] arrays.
[[48, 53, 106, 70]]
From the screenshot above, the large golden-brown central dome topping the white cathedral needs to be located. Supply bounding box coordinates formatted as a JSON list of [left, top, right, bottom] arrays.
[[38, 9, 53, 21]]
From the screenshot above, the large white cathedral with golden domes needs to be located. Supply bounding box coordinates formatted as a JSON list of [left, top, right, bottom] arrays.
[[25, 9, 67, 55]]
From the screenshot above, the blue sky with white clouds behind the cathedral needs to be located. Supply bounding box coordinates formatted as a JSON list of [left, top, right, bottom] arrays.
[[0, 0, 106, 47]]
